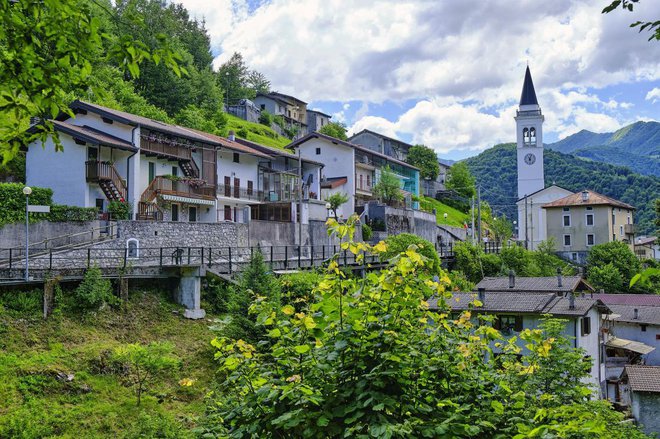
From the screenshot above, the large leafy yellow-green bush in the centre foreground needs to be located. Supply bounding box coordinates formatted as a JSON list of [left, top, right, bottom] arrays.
[[206, 220, 643, 439]]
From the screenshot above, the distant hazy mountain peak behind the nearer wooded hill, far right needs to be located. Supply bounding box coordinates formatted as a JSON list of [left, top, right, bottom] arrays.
[[547, 122, 660, 176]]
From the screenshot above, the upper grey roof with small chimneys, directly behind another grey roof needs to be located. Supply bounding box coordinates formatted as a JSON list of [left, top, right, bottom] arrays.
[[474, 276, 594, 293]]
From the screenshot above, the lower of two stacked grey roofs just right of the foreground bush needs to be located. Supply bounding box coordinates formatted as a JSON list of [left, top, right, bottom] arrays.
[[428, 292, 609, 316]]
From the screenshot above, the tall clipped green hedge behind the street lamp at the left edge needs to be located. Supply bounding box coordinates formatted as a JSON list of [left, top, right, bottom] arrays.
[[0, 183, 53, 225]]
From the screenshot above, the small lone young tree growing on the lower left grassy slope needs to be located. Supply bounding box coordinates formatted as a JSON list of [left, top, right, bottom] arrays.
[[113, 342, 180, 407]]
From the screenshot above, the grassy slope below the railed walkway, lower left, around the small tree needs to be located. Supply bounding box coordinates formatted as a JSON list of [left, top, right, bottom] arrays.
[[0, 290, 215, 438]]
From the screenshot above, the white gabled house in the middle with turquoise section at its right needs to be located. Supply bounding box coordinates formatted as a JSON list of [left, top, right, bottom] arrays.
[[289, 133, 420, 218]]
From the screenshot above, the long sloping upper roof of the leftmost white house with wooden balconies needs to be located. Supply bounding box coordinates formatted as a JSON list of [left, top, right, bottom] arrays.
[[64, 100, 215, 145]]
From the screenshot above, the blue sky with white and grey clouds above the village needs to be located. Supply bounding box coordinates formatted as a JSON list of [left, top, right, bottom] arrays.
[[176, 0, 660, 160]]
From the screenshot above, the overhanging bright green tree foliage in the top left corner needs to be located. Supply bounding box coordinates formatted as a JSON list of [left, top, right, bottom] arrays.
[[0, 0, 185, 162]]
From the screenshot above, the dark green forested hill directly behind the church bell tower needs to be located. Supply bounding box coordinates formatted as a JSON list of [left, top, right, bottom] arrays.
[[466, 143, 660, 234]]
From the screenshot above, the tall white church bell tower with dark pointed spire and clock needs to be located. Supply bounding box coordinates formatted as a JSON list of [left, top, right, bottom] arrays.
[[515, 66, 545, 199]]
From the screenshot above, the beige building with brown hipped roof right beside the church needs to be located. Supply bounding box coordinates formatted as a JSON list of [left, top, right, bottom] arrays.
[[543, 190, 636, 263]]
